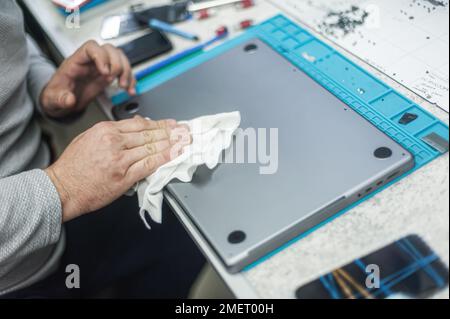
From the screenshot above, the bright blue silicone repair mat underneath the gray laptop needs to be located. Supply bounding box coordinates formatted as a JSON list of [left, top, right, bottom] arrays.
[[112, 15, 449, 269]]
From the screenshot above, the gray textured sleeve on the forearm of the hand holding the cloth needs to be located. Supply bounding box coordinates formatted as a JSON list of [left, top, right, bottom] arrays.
[[0, 170, 62, 269]]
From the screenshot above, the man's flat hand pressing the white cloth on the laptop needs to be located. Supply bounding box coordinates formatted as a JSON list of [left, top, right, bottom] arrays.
[[46, 117, 191, 222]]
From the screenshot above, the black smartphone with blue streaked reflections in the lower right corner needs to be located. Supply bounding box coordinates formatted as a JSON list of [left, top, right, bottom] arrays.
[[296, 235, 449, 299]]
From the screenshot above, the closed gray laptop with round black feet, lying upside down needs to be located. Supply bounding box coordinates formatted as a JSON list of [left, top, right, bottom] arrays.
[[115, 39, 414, 272]]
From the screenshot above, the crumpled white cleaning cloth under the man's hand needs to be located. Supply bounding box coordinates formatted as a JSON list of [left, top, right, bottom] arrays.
[[137, 112, 241, 228]]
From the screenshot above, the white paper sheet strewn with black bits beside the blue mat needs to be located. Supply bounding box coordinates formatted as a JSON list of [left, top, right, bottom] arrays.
[[270, 0, 449, 112]]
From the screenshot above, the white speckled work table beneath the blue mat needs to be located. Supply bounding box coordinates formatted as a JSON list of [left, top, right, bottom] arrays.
[[22, 0, 449, 298]]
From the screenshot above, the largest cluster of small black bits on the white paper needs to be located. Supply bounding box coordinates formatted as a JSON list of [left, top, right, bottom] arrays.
[[319, 6, 369, 37]]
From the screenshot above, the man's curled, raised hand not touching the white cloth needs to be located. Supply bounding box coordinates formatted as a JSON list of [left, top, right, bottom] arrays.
[[40, 41, 136, 118]]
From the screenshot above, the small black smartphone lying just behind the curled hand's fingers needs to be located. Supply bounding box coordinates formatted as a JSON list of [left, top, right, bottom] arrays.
[[119, 30, 173, 66]]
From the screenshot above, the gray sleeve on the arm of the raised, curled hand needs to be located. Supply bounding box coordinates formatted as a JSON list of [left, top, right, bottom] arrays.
[[27, 35, 55, 115]]
